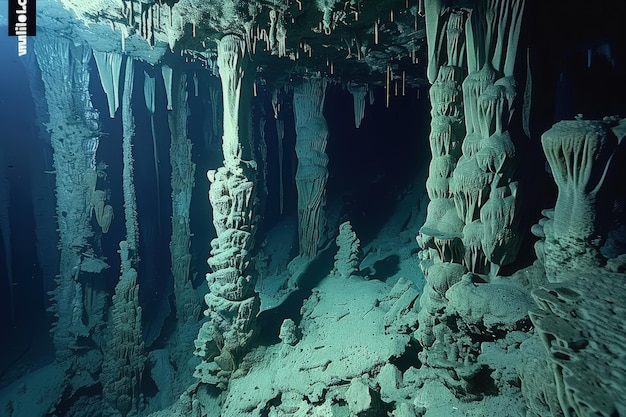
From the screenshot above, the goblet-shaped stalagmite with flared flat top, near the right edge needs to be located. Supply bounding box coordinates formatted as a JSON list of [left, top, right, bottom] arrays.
[[541, 120, 618, 282]]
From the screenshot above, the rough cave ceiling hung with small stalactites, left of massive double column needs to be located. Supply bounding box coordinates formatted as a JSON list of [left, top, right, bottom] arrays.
[[37, 0, 427, 87]]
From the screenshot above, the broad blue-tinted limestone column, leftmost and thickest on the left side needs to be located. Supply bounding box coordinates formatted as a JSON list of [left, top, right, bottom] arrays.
[[34, 33, 108, 370]]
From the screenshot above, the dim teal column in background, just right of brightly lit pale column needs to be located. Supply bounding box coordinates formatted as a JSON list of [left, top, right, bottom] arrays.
[[293, 77, 328, 258]]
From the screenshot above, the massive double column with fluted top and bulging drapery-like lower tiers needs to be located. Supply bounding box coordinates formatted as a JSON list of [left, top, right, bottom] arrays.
[[417, 0, 528, 398]]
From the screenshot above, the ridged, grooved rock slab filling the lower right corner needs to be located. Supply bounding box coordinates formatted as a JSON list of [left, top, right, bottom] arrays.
[[531, 269, 626, 417]]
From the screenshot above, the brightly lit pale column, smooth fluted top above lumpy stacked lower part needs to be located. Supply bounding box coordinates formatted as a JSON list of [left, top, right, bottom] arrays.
[[196, 34, 259, 386]]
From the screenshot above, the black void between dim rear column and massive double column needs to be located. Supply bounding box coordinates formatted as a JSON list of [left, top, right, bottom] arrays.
[[324, 85, 430, 244]]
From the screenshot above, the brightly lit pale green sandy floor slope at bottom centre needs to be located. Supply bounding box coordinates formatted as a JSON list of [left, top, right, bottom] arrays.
[[222, 278, 409, 417]]
